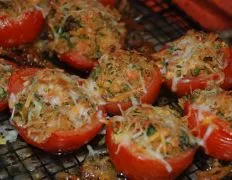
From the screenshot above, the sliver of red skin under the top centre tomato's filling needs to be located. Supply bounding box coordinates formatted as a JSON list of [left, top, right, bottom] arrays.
[[59, 52, 98, 71]]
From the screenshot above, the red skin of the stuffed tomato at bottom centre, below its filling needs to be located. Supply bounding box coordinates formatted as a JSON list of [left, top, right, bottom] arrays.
[[106, 123, 196, 180]]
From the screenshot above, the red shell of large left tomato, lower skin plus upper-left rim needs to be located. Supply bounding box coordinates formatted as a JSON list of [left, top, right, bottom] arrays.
[[9, 68, 105, 152]]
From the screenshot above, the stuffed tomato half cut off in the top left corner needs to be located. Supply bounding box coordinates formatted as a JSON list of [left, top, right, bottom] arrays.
[[0, 0, 44, 47]]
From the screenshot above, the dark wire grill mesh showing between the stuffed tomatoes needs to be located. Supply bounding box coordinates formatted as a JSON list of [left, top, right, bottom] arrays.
[[0, 0, 230, 180]]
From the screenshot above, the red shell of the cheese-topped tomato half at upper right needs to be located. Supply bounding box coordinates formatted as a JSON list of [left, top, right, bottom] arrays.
[[165, 49, 232, 96]]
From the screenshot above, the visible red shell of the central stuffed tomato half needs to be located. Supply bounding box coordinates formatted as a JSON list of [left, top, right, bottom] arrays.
[[105, 69, 162, 114]]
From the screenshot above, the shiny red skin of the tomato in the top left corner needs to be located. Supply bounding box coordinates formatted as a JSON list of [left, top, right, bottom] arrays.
[[0, 10, 44, 47]]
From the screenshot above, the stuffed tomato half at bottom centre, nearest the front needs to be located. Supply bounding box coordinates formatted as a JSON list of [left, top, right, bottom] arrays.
[[106, 105, 196, 180]]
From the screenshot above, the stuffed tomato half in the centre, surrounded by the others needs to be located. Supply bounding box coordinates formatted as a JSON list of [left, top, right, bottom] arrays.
[[83, 50, 162, 114]]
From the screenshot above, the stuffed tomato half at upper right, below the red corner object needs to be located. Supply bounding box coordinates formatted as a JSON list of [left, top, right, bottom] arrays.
[[153, 31, 232, 96]]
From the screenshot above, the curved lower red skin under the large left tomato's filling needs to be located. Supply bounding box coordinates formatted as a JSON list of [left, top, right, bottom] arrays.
[[14, 113, 103, 153]]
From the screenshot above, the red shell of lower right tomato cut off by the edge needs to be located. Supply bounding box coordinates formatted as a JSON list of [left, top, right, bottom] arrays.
[[185, 103, 232, 161]]
